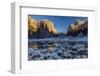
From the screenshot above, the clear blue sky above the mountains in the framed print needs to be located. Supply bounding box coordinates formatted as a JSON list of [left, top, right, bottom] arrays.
[[30, 15, 88, 32]]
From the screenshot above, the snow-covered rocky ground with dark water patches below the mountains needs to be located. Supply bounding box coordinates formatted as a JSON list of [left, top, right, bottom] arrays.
[[28, 37, 88, 60]]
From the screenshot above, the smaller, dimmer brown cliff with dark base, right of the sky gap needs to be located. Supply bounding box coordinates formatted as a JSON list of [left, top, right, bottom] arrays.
[[67, 20, 88, 36]]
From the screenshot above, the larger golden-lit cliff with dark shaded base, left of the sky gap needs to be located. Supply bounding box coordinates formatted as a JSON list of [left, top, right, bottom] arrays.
[[28, 16, 57, 38]]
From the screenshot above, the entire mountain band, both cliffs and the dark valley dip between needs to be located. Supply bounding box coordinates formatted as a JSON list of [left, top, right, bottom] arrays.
[[28, 16, 88, 38]]
